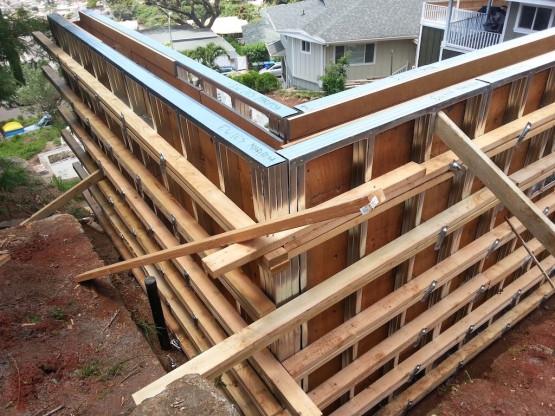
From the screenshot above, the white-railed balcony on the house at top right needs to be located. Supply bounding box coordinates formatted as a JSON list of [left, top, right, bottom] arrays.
[[422, 3, 501, 52]]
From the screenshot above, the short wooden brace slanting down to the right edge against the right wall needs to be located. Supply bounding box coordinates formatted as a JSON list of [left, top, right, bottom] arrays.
[[435, 111, 555, 256]]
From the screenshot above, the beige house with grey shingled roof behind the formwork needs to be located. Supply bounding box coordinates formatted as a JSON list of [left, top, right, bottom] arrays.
[[243, 0, 422, 90]]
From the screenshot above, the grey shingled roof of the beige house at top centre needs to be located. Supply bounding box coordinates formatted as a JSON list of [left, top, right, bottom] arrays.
[[265, 0, 423, 43]]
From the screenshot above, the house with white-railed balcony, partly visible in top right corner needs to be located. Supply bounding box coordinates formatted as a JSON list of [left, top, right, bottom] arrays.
[[418, 0, 555, 66]]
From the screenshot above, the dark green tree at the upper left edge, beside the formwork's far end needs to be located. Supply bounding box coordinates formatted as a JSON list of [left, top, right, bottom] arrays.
[[0, 8, 48, 102]]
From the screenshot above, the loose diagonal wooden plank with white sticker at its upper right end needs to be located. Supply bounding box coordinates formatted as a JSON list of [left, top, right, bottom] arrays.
[[75, 190, 385, 282]]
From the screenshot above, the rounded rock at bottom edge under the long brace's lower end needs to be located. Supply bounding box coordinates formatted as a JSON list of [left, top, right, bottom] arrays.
[[132, 374, 240, 416]]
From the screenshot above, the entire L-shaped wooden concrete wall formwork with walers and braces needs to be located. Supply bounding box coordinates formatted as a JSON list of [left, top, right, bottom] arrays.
[[33, 11, 555, 415]]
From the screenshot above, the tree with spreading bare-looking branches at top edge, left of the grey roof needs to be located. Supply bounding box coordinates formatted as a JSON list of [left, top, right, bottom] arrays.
[[145, 0, 220, 28]]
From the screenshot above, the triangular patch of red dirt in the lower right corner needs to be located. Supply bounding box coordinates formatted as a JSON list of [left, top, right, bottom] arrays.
[[408, 296, 555, 416]]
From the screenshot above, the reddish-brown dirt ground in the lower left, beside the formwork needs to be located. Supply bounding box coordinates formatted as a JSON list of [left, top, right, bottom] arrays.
[[0, 215, 165, 415]]
